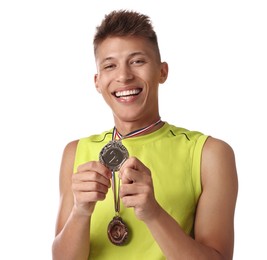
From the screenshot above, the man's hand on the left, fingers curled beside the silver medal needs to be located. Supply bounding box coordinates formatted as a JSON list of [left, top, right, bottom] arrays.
[[72, 161, 111, 216]]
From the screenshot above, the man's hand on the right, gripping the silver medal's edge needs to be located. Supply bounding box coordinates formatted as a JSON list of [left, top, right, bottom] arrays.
[[119, 157, 160, 221]]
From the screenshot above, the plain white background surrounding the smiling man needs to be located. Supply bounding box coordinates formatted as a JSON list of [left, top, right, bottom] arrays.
[[0, 0, 267, 260]]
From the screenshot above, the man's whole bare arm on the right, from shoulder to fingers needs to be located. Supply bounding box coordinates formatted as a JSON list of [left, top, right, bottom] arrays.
[[120, 137, 238, 260]]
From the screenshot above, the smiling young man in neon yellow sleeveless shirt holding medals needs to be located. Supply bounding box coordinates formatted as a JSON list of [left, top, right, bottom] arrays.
[[52, 10, 238, 260]]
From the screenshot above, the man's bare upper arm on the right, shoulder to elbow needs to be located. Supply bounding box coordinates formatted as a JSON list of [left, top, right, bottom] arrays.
[[195, 137, 238, 259]]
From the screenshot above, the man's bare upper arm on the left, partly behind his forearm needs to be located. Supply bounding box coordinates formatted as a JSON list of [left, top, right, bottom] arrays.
[[55, 141, 78, 235]]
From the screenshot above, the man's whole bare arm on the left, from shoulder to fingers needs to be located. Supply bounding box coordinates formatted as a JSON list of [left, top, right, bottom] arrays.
[[52, 141, 111, 260]]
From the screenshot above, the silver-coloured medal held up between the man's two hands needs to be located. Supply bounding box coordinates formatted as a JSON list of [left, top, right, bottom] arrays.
[[99, 141, 129, 171]]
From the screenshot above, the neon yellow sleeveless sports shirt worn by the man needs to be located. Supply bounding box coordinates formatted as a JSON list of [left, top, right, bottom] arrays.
[[74, 123, 207, 260]]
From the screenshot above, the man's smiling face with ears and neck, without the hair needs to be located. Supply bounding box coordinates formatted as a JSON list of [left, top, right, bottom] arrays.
[[95, 36, 168, 131]]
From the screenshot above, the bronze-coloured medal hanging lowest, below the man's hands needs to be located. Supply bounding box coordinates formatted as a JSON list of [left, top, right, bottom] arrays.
[[108, 216, 128, 246]]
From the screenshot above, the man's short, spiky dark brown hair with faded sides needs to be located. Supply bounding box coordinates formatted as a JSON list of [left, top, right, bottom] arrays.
[[93, 10, 160, 58]]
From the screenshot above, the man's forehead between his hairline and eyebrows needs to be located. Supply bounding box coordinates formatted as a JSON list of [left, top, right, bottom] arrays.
[[95, 36, 156, 61]]
